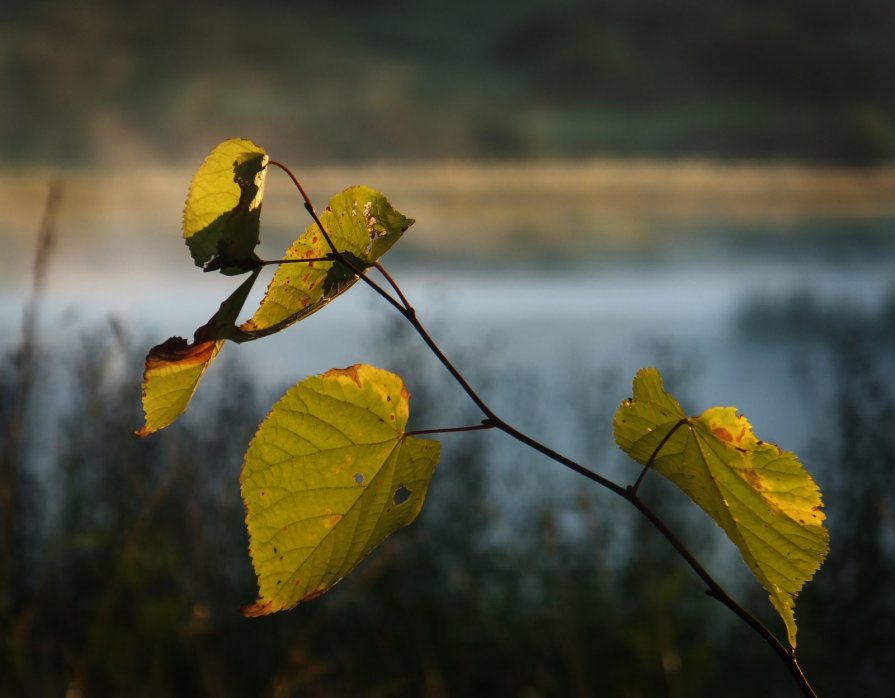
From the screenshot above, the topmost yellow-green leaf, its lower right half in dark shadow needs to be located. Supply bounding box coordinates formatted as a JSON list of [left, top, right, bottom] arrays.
[[183, 138, 268, 275]]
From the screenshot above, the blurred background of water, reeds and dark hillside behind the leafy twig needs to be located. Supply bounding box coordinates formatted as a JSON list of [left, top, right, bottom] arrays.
[[0, 0, 895, 697]]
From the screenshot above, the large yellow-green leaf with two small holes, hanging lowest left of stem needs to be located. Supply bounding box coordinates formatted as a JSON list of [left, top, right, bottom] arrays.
[[241, 364, 440, 616]]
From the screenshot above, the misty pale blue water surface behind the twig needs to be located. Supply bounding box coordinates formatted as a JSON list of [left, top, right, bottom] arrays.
[[0, 215, 895, 462]]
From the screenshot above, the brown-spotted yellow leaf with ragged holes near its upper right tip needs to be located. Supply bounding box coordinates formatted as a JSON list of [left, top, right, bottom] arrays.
[[233, 186, 413, 341]]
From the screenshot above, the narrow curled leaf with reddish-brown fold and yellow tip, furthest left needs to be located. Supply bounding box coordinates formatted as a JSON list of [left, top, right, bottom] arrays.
[[135, 269, 259, 436]]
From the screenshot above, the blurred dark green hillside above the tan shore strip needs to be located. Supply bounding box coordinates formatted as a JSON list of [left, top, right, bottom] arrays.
[[7, 0, 895, 165]]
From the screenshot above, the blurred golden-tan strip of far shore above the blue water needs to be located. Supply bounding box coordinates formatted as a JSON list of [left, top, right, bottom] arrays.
[[0, 159, 895, 253]]
